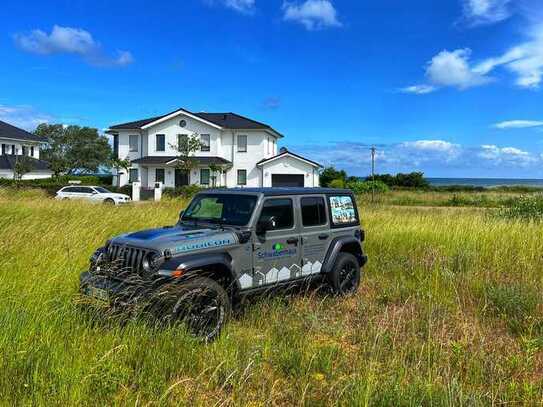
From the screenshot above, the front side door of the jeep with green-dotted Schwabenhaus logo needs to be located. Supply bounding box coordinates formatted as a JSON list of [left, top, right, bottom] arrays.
[[253, 196, 302, 287]]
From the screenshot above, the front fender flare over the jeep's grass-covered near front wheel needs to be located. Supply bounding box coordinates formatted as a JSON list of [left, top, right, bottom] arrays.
[[155, 252, 239, 288]]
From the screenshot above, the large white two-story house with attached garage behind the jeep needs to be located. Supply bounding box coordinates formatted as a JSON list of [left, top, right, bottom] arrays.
[[106, 109, 321, 188]]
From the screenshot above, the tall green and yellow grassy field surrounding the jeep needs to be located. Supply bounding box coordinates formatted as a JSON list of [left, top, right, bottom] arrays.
[[0, 191, 543, 406]]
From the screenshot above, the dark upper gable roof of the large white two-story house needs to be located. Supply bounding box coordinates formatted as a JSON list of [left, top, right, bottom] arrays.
[[109, 109, 283, 137]]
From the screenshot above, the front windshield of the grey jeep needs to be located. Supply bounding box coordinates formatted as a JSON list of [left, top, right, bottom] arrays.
[[181, 194, 257, 226]]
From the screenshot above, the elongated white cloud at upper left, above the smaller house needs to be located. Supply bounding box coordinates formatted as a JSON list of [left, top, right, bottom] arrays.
[[14, 25, 134, 66]]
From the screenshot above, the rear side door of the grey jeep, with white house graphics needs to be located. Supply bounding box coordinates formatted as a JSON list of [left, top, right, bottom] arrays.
[[299, 195, 332, 276]]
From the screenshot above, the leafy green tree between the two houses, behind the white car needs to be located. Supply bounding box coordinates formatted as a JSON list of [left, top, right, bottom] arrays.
[[34, 123, 111, 176]]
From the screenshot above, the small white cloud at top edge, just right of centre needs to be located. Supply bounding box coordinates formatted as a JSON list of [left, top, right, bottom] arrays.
[[283, 0, 342, 30]]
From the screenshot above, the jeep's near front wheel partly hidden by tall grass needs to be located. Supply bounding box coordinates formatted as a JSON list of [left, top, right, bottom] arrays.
[[153, 277, 232, 342]]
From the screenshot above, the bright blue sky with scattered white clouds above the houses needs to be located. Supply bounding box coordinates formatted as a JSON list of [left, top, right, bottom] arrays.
[[0, 0, 543, 178]]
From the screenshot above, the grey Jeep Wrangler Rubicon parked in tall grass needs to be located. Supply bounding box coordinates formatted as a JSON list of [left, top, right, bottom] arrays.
[[80, 188, 367, 340]]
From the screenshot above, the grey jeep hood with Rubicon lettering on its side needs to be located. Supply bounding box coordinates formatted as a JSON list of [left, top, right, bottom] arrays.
[[111, 225, 238, 255]]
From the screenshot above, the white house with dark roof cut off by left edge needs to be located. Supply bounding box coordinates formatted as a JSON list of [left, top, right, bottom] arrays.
[[0, 120, 53, 179]]
